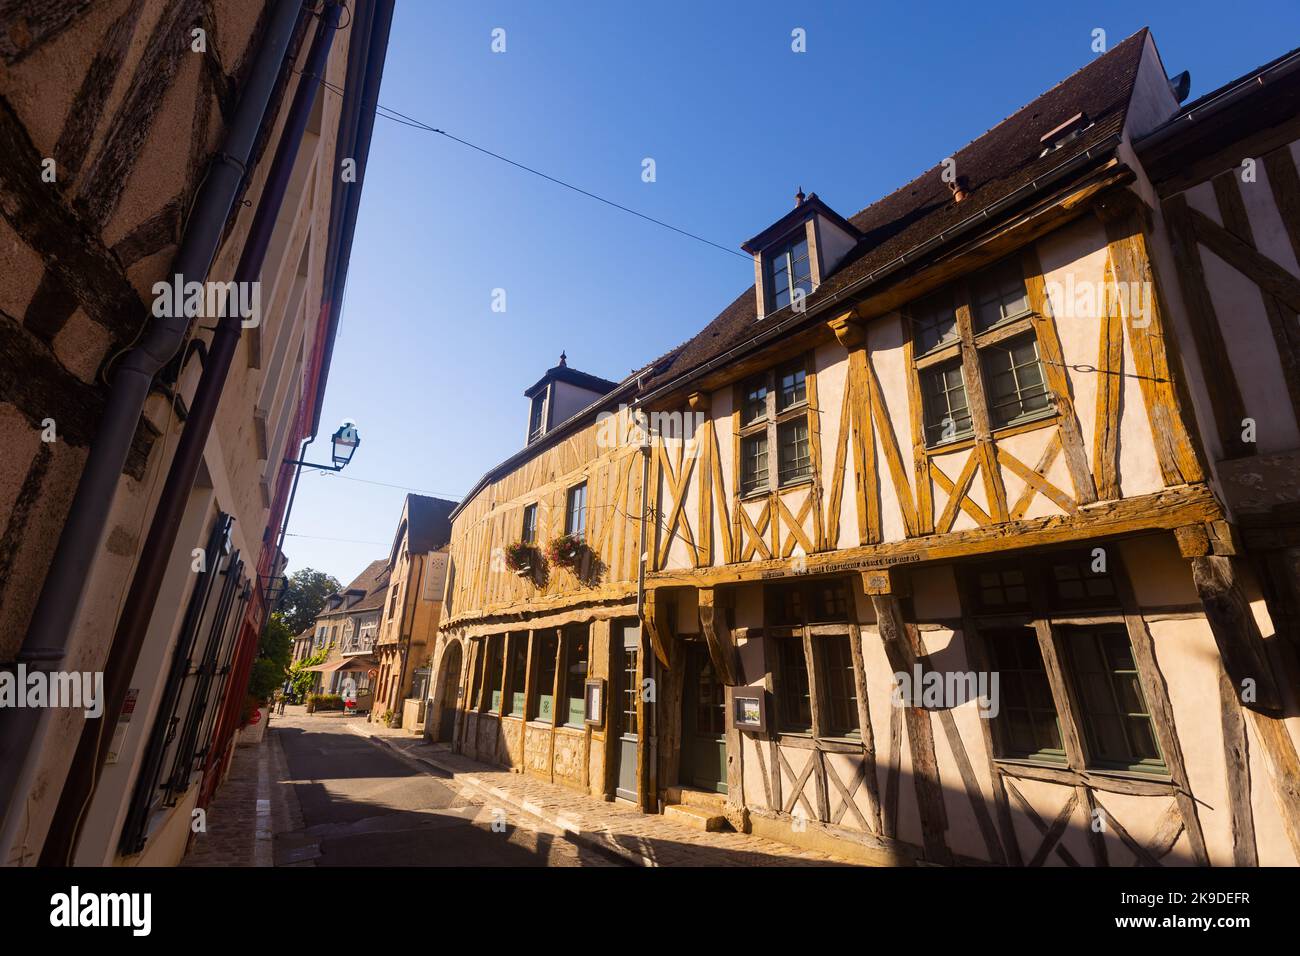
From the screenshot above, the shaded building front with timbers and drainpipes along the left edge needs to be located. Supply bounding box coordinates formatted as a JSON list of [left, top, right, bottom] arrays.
[[0, 0, 393, 865]]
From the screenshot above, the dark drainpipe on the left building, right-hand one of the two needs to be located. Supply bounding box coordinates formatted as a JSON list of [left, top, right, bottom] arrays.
[[42, 0, 342, 865]]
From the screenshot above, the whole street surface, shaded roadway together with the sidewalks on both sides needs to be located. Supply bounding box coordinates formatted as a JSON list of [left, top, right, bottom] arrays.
[[185, 708, 841, 866]]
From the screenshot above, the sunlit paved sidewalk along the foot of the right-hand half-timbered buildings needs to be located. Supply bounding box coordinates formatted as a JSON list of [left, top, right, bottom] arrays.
[[343, 718, 854, 866]]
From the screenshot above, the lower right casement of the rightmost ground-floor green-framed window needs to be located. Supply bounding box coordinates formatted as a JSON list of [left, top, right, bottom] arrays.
[[1062, 624, 1167, 774]]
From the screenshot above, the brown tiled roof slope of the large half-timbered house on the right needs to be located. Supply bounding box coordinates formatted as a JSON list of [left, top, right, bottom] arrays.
[[649, 27, 1148, 388]]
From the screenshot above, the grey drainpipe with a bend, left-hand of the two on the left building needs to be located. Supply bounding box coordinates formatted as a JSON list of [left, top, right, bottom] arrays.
[[0, 0, 307, 860]]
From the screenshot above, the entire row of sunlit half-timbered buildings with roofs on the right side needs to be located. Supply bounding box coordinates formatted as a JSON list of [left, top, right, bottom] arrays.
[[426, 31, 1300, 865]]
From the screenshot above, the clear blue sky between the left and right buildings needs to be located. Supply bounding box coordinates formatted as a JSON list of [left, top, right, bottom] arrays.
[[285, 0, 1300, 583]]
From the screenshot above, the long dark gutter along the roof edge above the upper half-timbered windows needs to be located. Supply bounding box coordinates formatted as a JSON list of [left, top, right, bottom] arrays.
[[632, 133, 1123, 407]]
